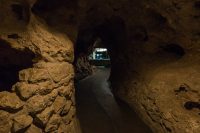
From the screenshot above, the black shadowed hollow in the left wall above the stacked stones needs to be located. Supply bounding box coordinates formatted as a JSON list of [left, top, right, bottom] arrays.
[[0, 40, 35, 91]]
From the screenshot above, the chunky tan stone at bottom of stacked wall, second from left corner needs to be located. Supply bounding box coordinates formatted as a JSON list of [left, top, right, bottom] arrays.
[[12, 115, 33, 132]]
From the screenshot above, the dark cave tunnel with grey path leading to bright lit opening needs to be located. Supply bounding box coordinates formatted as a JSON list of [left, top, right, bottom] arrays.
[[75, 16, 151, 133]]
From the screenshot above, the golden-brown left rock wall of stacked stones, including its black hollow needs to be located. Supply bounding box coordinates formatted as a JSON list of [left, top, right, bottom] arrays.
[[0, 0, 77, 133]]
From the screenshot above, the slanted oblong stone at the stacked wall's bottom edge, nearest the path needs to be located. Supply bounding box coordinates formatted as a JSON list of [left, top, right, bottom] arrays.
[[45, 114, 61, 132]]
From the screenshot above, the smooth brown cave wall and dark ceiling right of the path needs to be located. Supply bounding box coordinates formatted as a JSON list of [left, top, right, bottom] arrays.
[[72, 0, 200, 133]]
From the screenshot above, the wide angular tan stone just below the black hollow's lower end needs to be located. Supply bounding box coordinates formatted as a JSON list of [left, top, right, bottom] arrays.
[[14, 82, 39, 100]]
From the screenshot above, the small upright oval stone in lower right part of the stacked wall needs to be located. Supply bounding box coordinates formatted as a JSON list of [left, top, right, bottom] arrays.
[[53, 96, 66, 114]]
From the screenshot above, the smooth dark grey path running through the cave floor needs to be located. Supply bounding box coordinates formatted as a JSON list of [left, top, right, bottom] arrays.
[[76, 68, 151, 133]]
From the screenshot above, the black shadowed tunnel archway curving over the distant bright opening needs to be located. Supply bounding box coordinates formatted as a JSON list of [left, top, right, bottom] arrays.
[[75, 16, 128, 90]]
